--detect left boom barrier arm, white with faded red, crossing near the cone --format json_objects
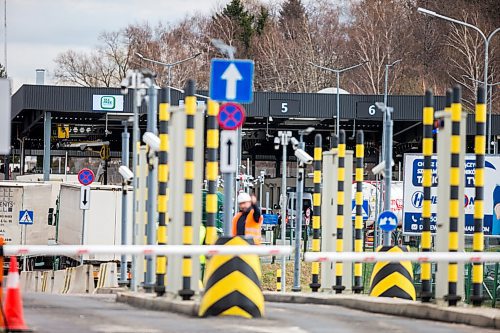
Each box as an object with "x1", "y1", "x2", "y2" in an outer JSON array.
[{"x1": 3, "y1": 245, "x2": 292, "y2": 256}]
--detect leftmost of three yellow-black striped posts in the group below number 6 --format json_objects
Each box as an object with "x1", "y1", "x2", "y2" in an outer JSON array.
[{"x1": 309, "y1": 134, "x2": 323, "y2": 292}]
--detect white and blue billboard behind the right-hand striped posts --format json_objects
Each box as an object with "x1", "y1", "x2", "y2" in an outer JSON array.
[{"x1": 403, "y1": 154, "x2": 500, "y2": 237}]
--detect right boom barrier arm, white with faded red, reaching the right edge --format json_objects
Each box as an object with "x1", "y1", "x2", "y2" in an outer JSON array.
[{"x1": 304, "y1": 252, "x2": 500, "y2": 262}]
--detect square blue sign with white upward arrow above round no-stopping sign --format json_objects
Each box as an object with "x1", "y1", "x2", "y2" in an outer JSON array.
[{"x1": 210, "y1": 59, "x2": 254, "y2": 103}]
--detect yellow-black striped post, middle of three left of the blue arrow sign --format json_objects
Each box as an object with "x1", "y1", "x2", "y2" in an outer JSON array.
[{"x1": 179, "y1": 80, "x2": 196, "y2": 300}]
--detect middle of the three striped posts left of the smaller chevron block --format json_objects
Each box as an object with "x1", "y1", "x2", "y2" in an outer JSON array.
[{"x1": 332, "y1": 130, "x2": 345, "y2": 294}]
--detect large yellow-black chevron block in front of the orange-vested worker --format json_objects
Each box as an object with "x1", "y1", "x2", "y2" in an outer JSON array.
[{"x1": 198, "y1": 236, "x2": 264, "y2": 318}]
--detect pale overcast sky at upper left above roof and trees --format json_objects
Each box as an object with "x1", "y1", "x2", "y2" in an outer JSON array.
[{"x1": 0, "y1": 0, "x2": 238, "y2": 89}]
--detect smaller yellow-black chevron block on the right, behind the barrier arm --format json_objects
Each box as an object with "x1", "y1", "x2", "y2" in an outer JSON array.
[{"x1": 370, "y1": 246, "x2": 416, "y2": 301}]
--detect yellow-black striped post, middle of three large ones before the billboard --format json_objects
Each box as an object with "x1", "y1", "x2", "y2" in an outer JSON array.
[{"x1": 444, "y1": 87, "x2": 462, "y2": 306}]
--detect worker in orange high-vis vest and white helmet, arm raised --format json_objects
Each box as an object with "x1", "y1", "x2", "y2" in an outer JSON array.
[{"x1": 232, "y1": 192, "x2": 263, "y2": 244}]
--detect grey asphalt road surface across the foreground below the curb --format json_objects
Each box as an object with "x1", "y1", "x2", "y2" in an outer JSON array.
[{"x1": 24, "y1": 294, "x2": 498, "y2": 333}]
